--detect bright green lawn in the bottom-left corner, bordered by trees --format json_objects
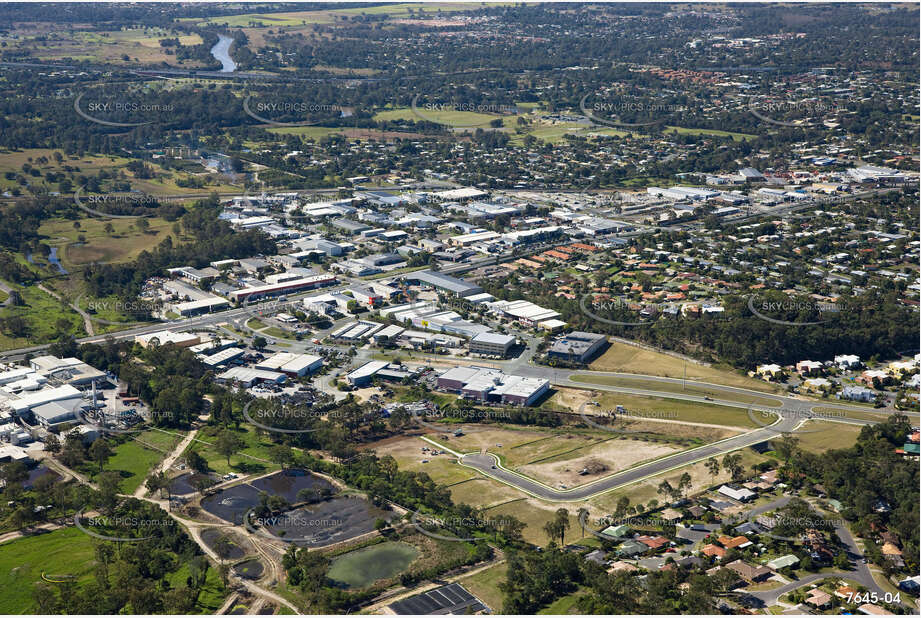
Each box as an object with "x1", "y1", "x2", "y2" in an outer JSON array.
[{"x1": 0, "y1": 528, "x2": 96, "y2": 614}]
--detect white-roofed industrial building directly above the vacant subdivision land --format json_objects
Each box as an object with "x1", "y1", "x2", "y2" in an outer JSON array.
[{"x1": 437, "y1": 366, "x2": 550, "y2": 406}]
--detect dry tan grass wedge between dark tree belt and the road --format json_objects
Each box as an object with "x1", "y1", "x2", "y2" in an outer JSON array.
[{"x1": 589, "y1": 341, "x2": 778, "y2": 393}]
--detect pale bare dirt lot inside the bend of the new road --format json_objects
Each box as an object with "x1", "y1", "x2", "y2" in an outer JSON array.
[{"x1": 516, "y1": 439, "x2": 680, "y2": 487}]
